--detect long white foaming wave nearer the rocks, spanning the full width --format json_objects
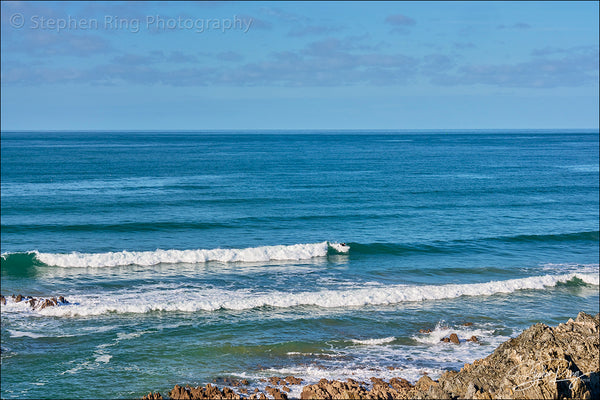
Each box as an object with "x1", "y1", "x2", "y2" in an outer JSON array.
[{"x1": 2, "y1": 273, "x2": 599, "y2": 316}]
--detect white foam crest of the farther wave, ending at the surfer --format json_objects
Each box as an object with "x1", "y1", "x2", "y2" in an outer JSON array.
[{"x1": 34, "y1": 242, "x2": 350, "y2": 268}]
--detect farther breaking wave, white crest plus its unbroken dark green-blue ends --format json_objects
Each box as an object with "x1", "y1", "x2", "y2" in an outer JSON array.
[{"x1": 1, "y1": 231, "x2": 600, "y2": 273}]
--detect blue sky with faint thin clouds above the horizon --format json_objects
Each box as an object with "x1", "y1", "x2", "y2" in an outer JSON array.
[{"x1": 0, "y1": 1, "x2": 599, "y2": 131}]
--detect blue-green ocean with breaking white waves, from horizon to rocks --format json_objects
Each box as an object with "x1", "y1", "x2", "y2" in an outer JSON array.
[{"x1": 0, "y1": 130, "x2": 599, "y2": 398}]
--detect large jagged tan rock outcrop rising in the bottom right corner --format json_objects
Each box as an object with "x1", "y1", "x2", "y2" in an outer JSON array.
[{"x1": 418, "y1": 313, "x2": 600, "y2": 399}]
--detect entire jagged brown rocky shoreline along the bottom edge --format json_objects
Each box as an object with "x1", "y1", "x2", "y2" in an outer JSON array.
[{"x1": 142, "y1": 312, "x2": 600, "y2": 400}]
